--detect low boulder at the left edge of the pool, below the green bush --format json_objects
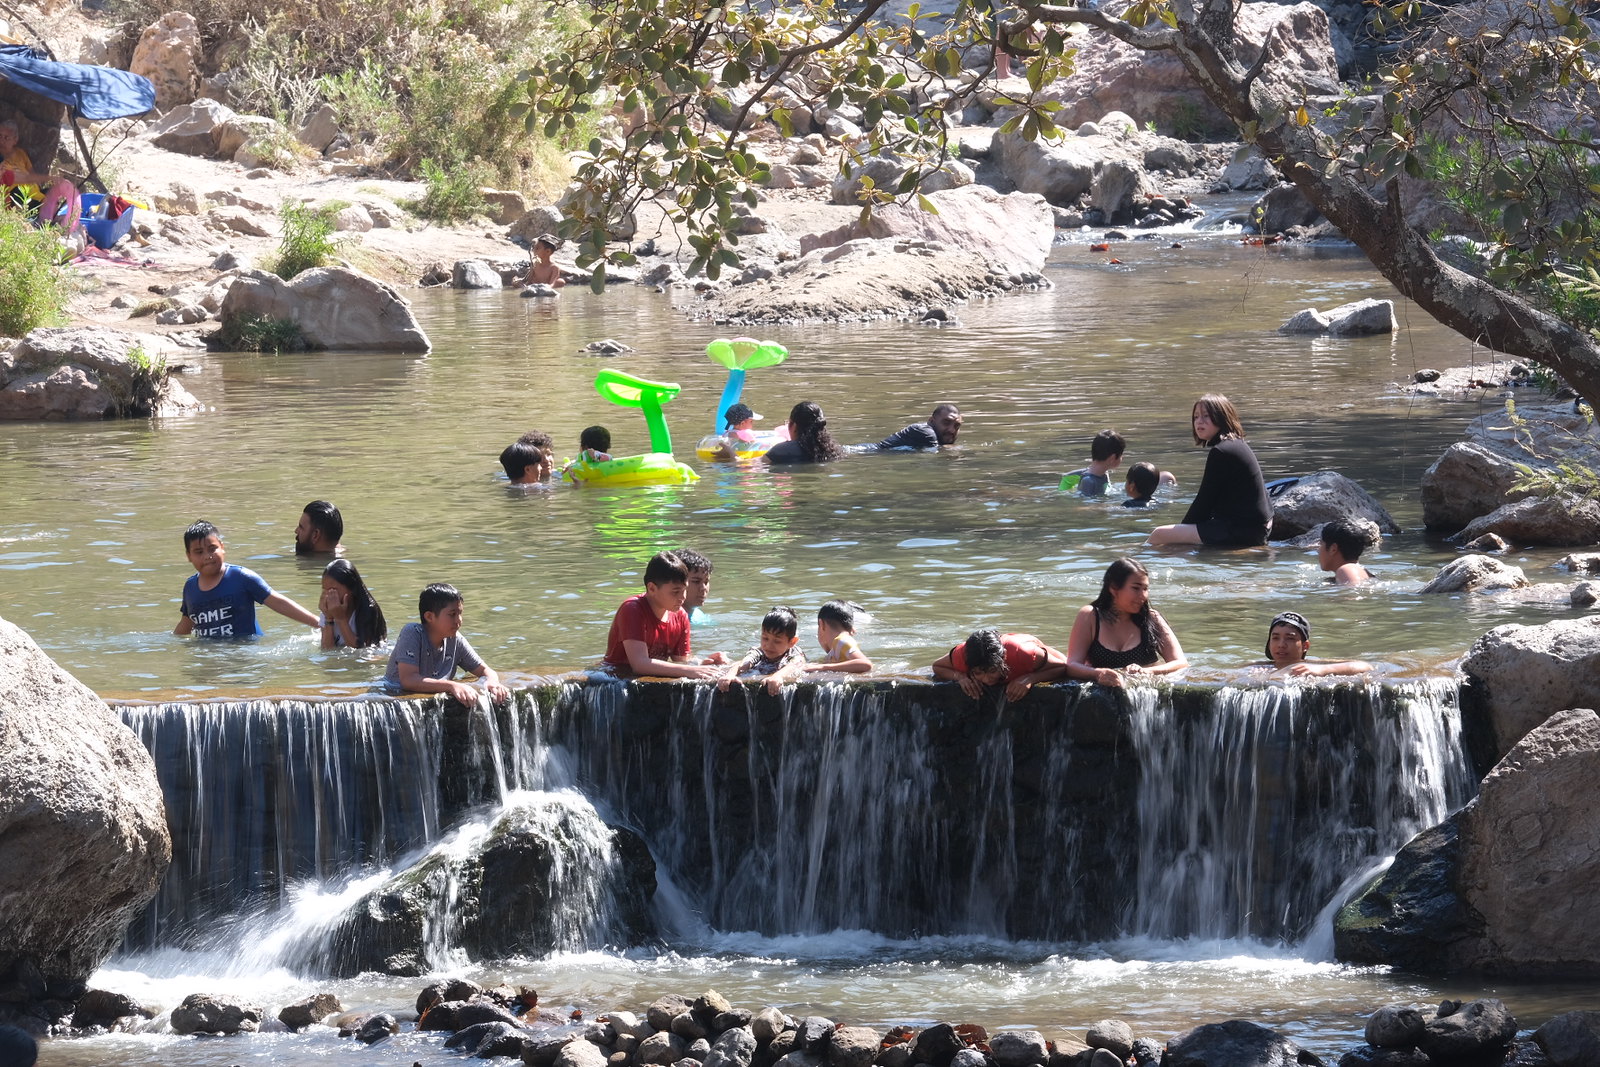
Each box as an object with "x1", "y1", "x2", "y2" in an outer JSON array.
[{"x1": 0, "y1": 326, "x2": 200, "y2": 419}]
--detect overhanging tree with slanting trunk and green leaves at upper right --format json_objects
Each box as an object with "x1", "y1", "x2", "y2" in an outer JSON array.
[{"x1": 520, "y1": 0, "x2": 1600, "y2": 402}]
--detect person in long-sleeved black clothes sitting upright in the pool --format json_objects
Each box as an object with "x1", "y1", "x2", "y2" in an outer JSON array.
[{"x1": 1150, "y1": 394, "x2": 1272, "y2": 547}]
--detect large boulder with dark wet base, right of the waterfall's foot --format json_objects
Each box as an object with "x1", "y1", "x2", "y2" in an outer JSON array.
[{"x1": 1334, "y1": 709, "x2": 1600, "y2": 979}]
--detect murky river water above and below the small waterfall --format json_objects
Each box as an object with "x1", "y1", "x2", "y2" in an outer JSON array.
[{"x1": 9, "y1": 220, "x2": 1594, "y2": 1065}]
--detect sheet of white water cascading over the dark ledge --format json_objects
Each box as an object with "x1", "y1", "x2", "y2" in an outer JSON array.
[{"x1": 122, "y1": 680, "x2": 1474, "y2": 966}]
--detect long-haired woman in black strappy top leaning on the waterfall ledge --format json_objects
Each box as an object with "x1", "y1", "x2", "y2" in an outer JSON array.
[{"x1": 1067, "y1": 557, "x2": 1189, "y2": 686}]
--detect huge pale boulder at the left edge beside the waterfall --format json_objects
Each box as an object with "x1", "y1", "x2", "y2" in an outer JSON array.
[{"x1": 0, "y1": 619, "x2": 173, "y2": 1030}]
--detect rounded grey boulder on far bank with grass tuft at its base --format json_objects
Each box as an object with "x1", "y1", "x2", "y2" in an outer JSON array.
[{"x1": 218, "y1": 267, "x2": 430, "y2": 352}]
